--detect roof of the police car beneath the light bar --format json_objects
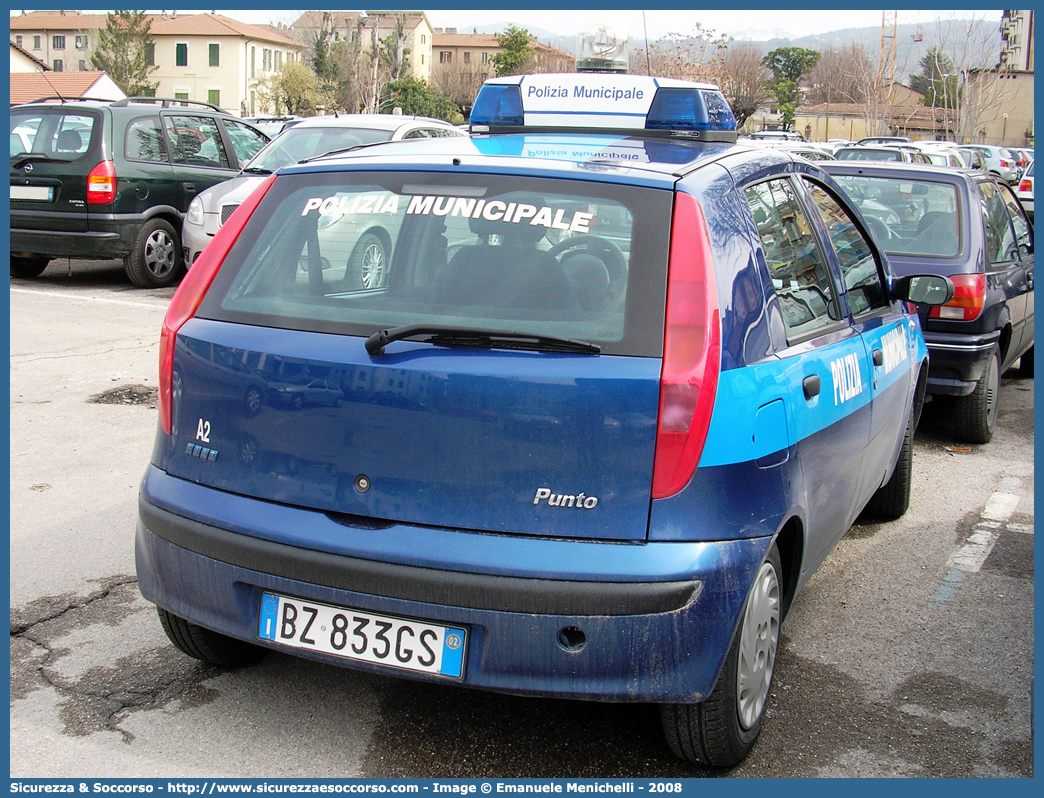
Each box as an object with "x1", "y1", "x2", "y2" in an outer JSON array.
[{"x1": 280, "y1": 133, "x2": 794, "y2": 185}]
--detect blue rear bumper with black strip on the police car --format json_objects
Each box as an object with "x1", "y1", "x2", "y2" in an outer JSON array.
[{"x1": 136, "y1": 467, "x2": 770, "y2": 703}]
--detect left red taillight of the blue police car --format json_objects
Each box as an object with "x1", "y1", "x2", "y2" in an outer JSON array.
[{"x1": 157, "y1": 175, "x2": 276, "y2": 435}]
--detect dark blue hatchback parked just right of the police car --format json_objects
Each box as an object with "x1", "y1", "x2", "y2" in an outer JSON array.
[{"x1": 824, "y1": 163, "x2": 1034, "y2": 443}]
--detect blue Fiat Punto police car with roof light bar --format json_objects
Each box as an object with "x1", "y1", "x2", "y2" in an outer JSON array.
[{"x1": 137, "y1": 74, "x2": 952, "y2": 766}]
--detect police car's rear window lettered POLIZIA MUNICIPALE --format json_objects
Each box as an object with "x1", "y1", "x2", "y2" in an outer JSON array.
[{"x1": 198, "y1": 171, "x2": 673, "y2": 356}]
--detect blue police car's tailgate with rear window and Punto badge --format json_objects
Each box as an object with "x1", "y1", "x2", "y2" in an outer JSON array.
[{"x1": 163, "y1": 168, "x2": 672, "y2": 540}]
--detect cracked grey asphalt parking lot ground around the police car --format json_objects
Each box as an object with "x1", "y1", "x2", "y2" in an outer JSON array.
[{"x1": 10, "y1": 261, "x2": 1034, "y2": 777}]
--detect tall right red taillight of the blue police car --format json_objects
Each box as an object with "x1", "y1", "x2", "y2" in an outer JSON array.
[{"x1": 653, "y1": 193, "x2": 721, "y2": 498}]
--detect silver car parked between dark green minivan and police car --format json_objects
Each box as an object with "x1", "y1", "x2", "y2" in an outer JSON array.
[{"x1": 182, "y1": 114, "x2": 467, "y2": 277}]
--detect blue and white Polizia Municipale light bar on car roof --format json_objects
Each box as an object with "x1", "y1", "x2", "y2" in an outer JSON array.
[{"x1": 471, "y1": 73, "x2": 736, "y2": 142}]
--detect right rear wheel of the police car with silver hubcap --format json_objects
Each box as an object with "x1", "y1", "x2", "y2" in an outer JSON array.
[{"x1": 660, "y1": 544, "x2": 783, "y2": 768}]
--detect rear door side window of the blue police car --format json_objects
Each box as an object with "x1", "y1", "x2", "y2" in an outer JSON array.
[{"x1": 744, "y1": 178, "x2": 840, "y2": 343}]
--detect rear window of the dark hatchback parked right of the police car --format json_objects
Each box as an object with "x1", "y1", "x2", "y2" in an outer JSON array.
[{"x1": 834, "y1": 174, "x2": 963, "y2": 258}]
